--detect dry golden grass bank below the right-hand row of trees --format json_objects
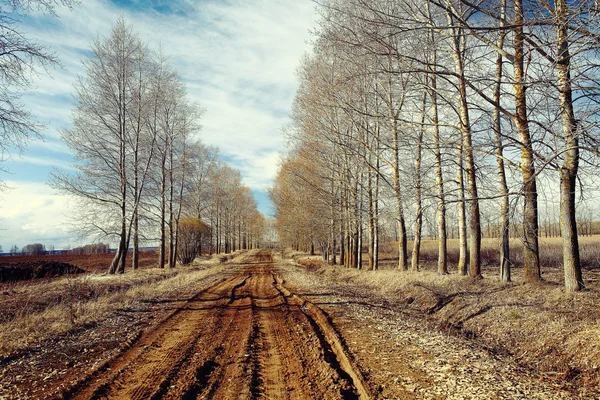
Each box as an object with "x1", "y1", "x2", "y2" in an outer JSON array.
[{"x1": 286, "y1": 253, "x2": 600, "y2": 390}]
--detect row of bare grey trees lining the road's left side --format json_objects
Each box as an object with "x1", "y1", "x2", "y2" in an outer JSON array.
[{"x1": 51, "y1": 19, "x2": 262, "y2": 273}]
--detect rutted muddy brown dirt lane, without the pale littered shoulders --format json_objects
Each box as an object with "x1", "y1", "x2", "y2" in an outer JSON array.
[{"x1": 65, "y1": 250, "x2": 370, "y2": 399}]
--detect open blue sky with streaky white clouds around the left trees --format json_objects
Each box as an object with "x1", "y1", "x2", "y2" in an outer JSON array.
[{"x1": 0, "y1": 0, "x2": 317, "y2": 251}]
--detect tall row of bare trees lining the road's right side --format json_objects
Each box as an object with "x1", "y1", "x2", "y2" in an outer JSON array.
[{"x1": 272, "y1": 0, "x2": 600, "y2": 291}]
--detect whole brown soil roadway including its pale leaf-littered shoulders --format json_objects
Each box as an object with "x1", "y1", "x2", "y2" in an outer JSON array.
[{"x1": 0, "y1": 250, "x2": 594, "y2": 399}]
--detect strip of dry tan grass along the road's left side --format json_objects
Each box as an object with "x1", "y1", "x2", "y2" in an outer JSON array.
[{"x1": 0, "y1": 257, "x2": 224, "y2": 358}]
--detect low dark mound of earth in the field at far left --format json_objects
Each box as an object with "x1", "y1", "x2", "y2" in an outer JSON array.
[{"x1": 0, "y1": 260, "x2": 85, "y2": 282}]
